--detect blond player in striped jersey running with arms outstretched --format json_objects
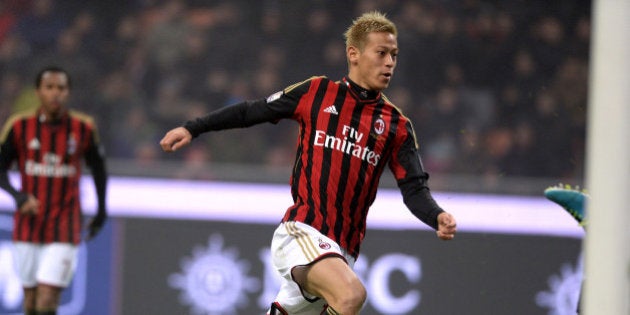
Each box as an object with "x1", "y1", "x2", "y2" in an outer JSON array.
[{"x1": 160, "y1": 12, "x2": 456, "y2": 315}]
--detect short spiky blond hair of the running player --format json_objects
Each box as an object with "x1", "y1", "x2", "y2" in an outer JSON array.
[{"x1": 343, "y1": 11, "x2": 398, "y2": 51}]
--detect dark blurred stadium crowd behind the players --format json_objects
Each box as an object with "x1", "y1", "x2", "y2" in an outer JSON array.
[{"x1": 0, "y1": 0, "x2": 591, "y2": 188}]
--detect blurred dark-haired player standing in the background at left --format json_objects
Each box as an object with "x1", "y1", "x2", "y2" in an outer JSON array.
[{"x1": 0, "y1": 67, "x2": 107, "y2": 315}]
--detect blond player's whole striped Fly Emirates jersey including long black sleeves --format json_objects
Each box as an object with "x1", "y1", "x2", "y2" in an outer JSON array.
[{"x1": 184, "y1": 77, "x2": 443, "y2": 257}]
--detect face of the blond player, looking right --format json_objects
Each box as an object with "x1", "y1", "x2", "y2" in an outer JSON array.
[{"x1": 356, "y1": 32, "x2": 398, "y2": 91}]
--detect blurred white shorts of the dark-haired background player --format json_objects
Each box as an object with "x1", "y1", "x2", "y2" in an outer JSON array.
[{"x1": 13, "y1": 242, "x2": 78, "y2": 288}]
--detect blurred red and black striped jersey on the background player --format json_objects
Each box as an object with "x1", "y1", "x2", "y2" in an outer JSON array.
[{"x1": 0, "y1": 110, "x2": 102, "y2": 244}]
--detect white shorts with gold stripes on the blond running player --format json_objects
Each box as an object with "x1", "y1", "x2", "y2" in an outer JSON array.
[{"x1": 268, "y1": 221, "x2": 354, "y2": 315}]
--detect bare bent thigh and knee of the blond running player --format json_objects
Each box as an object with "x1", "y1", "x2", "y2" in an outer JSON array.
[{"x1": 293, "y1": 256, "x2": 364, "y2": 299}]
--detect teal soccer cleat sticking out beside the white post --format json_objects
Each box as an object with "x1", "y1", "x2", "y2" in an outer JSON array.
[{"x1": 544, "y1": 184, "x2": 589, "y2": 226}]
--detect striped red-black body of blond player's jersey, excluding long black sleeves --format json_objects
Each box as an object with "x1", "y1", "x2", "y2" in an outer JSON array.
[{"x1": 283, "y1": 78, "x2": 442, "y2": 256}]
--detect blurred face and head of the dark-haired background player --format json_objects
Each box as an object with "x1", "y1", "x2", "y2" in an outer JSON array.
[{"x1": 37, "y1": 72, "x2": 70, "y2": 116}]
